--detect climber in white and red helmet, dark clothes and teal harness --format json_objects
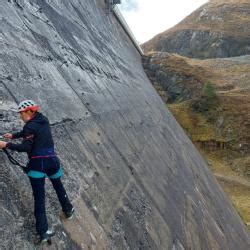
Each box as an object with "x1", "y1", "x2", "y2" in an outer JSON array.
[{"x1": 0, "y1": 100, "x2": 74, "y2": 243}]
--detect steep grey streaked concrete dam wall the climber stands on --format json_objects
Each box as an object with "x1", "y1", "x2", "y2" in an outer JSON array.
[{"x1": 0, "y1": 0, "x2": 250, "y2": 250}]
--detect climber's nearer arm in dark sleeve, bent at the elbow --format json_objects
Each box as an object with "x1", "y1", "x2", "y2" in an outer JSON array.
[{"x1": 6, "y1": 126, "x2": 35, "y2": 153}]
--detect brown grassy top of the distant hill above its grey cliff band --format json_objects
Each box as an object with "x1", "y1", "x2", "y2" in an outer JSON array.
[{"x1": 167, "y1": 1, "x2": 250, "y2": 37}]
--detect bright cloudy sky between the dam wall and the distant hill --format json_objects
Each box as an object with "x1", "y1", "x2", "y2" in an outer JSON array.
[{"x1": 118, "y1": 0, "x2": 208, "y2": 43}]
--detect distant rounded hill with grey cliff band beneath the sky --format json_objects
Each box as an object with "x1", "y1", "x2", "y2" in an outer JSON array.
[{"x1": 143, "y1": 0, "x2": 250, "y2": 58}]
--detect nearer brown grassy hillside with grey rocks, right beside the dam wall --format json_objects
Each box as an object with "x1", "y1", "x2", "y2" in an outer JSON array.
[{"x1": 143, "y1": 52, "x2": 250, "y2": 224}]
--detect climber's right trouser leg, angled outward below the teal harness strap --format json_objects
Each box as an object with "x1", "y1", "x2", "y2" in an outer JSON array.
[{"x1": 50, "y1": 177, "x2": 73, "y2": 213}]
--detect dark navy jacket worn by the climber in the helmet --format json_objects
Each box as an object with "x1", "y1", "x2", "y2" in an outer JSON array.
[{"x1": 7, "y1": 112, "x2": 54, "y2": 159}]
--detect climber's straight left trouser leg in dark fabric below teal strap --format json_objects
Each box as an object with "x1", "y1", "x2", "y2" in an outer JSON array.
[{"x1": 29, "y1": 177, "x2": 48, "y2": 236}]
